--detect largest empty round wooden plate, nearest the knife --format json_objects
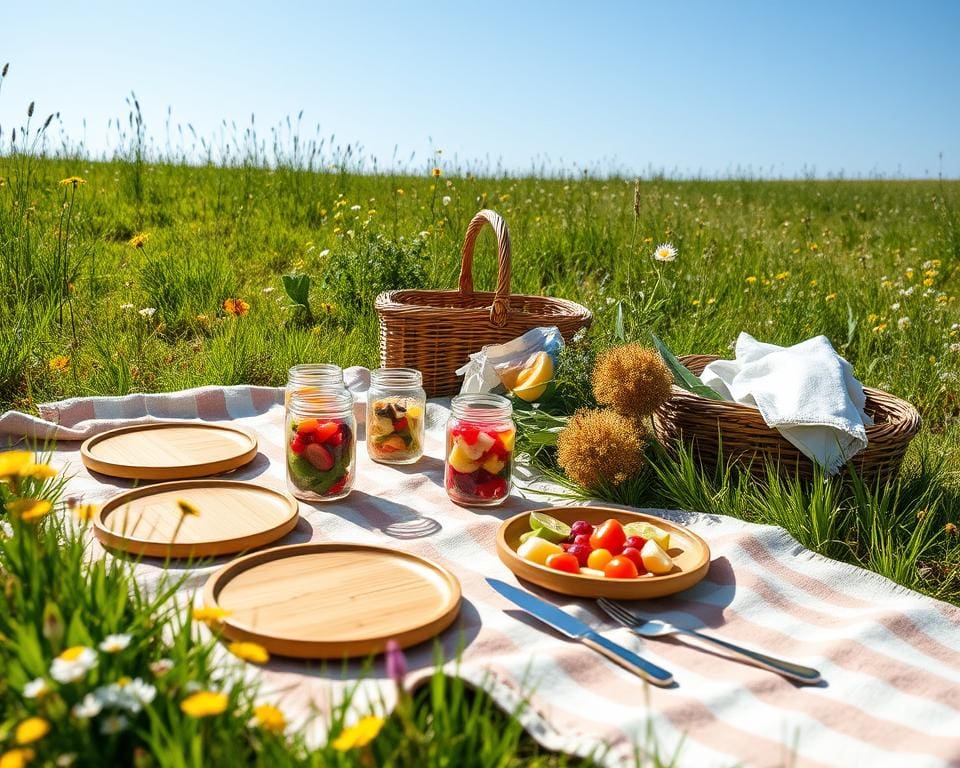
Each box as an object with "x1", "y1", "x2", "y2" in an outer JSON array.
[{"x1": 204, "y1": 543, "x2": 460, "y2": 659}]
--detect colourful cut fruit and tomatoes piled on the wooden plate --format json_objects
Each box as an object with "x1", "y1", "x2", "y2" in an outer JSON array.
[{"x1": 517, "y1": 512, "x2": 675, "y2": 579}]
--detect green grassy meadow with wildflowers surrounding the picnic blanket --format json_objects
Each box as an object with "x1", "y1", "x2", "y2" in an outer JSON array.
[{"x1": 0, "y1": 97, "x2": 960, "y2": 765}]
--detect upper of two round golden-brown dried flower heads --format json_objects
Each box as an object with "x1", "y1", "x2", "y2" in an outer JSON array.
[{"x1": 593, "y1": 344, "x2": 673, "y2": 417}]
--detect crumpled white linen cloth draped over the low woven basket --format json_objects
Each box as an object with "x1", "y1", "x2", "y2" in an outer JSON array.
[{"x1": 700, "y1": 333, "x2": 873, "y2": 475}]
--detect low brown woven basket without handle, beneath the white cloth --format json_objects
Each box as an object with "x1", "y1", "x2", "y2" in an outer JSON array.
[{"x1": 653, "y1": 355, "x2": 920, "y2": 483}]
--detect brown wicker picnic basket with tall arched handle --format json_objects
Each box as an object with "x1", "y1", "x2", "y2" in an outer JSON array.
[{"x1": 376, "y1": 210, "x2": 593, "y2": 397}]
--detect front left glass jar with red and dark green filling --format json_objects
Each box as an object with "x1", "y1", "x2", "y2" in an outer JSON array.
[{"x1": 284, "y1": 389, "x2": 357, "y2": 501}]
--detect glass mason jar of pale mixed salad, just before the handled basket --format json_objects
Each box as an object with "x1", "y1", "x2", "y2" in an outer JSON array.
[{"x1": 367, "y1": 368, "x2": 427, "y2": 464}]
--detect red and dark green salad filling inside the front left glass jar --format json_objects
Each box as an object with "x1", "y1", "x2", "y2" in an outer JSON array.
[{"x1": 287, "y1": 418, "x2": 356, "y2": 500}]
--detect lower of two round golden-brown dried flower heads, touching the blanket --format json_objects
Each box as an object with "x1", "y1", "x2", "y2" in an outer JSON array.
[{"x1": 557, "y1": 410, "x2": 646, "y2": 488}]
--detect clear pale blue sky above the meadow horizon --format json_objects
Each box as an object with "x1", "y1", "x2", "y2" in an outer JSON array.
[{"x1": 0, "y1": 0, "x2": 960, "y2": 177}]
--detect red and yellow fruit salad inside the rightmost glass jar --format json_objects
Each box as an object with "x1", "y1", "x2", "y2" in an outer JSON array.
[{"x1": 445, "y1": 421, "x2": 516, "y2": 506}]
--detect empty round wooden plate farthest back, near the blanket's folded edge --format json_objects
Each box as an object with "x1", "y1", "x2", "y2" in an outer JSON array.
[{"x1": 80, "y1": 421, "x2": 257, "y2": 480}]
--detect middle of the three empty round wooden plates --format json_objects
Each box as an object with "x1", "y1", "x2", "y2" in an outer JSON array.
[{"x1": 94, "y1": 480, "x2": 300, "y2": 557}]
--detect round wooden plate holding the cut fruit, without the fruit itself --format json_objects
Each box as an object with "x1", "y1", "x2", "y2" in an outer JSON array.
[{"x1": 497, "y1": 507, "x2": 710, "y2": 600}]
